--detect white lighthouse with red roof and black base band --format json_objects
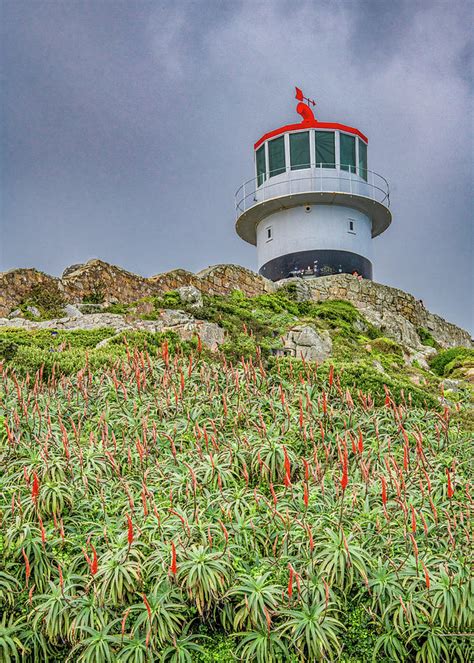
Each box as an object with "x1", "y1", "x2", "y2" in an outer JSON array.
[{"x1": 235, "y1": 88, "x2": 392, "y2": 281}]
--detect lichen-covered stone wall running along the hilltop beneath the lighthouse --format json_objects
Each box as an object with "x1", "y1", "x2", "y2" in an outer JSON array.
[{"x1": 0, "y1": 260, "x2": 471, "y2": 350}]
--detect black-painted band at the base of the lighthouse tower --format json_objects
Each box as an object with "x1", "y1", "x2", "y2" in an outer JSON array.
[{"x1": 259, "y1": 249, "x2": 372, "y2": 281}]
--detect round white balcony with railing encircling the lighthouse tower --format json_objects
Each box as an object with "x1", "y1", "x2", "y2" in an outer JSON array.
[{"x1": 235, "y1": 167, "x2": 392, "y2": 244}]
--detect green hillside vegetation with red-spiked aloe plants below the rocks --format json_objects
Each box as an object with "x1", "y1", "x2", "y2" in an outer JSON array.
[{"x1": 0, "y1": 290, "x2": 474, "y2": 663}]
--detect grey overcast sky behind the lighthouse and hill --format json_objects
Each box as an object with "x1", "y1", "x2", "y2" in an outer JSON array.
[{"x1": 0, "y1": 0, "x2": 474, "y2": 329}]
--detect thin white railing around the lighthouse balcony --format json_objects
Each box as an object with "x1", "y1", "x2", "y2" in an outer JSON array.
[{"x1": 235, "y1": 166, "x2": 390, "y2": 218}]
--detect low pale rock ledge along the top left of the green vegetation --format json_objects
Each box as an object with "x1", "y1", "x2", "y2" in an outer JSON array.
[{"x1": 0, "y1": 309, "x2": 225, "y2": 351}]
